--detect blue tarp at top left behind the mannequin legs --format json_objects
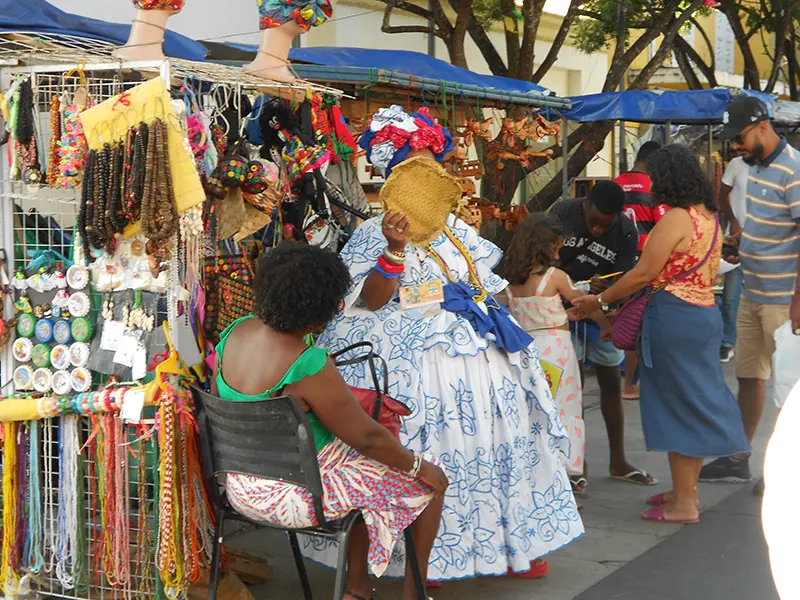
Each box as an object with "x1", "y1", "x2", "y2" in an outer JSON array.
[{"x1": 0, "y1": 0, "x2": 206, "y2": 61}]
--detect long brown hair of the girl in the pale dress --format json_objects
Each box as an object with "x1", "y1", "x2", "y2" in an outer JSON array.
[{"x1": 505, "y1": 213, "x2": 564, "y2": 285}]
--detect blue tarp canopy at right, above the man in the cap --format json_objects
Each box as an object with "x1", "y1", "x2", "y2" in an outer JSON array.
[{"x1": 562, "y1": 88, "x2": 775, "y2": 125}]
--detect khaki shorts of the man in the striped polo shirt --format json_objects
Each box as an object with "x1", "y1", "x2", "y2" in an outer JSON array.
[{"x1": 736, "y1": 298, "x2": 789, "y2": 380}]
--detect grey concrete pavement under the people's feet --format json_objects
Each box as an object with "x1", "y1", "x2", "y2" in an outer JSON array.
[{"x1": 226, "y1": 366, "x2": 777, "y2": 600}]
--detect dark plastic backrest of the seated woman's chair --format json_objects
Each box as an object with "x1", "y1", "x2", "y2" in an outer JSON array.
[{"x1": 192, "y1": 387, "x2": 326, "y2": 527}]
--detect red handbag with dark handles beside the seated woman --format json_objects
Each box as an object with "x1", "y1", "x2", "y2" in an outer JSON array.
[{"x1": 331, "y1": 342, "x2": 411, "y2": 439}]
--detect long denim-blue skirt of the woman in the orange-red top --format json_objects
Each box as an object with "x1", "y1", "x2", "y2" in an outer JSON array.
[{"x1": 638, "y1": 291, "x2": 750, "y2": 458}]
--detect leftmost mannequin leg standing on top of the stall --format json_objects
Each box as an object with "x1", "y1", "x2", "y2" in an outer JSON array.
[{"x1": 113, "y1": 0, "x2": 184, "y2": 61}]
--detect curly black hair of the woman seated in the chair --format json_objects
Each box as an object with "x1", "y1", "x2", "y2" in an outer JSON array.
[{"x1": 253, "y1": 242, "x2": 350, "y2": 334}]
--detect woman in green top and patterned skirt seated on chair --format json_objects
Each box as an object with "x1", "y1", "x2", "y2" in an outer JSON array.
[{"x1": 212, "y1": 243, "x2": 448, "y2": 600}]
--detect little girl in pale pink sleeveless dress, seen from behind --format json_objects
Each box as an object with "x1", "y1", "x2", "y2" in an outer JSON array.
[{"x1": 505, "y1": 213, "x2": 610, "y2": 475}]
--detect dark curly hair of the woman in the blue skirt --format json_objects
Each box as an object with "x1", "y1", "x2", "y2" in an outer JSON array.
[{"x1": 647, "y1": 144, "x2": 717, "y2": 212}]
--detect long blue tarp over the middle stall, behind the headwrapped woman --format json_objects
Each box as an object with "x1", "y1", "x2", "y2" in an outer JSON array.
[{"x1": 289, "y1": 47, "x2": 550, "y2": 94}]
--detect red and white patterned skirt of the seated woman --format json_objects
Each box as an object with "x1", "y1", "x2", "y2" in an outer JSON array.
[{"x1": 227, "y1": 439, "x2": 433, "y2": 577}]
